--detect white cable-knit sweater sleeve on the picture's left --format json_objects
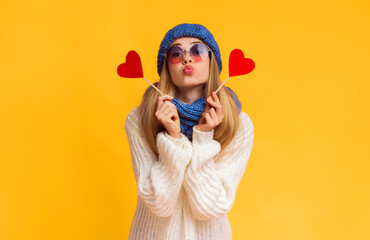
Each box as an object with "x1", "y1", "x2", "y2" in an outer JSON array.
[{"x1": 125, "y1": 108, "x2": 192, "y2": 217}]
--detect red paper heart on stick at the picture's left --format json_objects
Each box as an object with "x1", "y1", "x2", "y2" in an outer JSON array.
[{"x1": 117, "y1": 50, "x2": 144, "y2": 78}]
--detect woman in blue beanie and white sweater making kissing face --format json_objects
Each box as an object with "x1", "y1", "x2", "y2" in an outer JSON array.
[{"x1": 125, "y1": 24, "x2": 254, "y2": 240}]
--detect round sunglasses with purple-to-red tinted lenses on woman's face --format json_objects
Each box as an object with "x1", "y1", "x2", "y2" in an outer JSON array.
[{"x1": 164, "y1": 43, "x2": 211, "y2": 64}]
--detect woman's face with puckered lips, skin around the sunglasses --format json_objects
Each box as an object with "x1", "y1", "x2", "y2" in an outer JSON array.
[{"x1": 167, "y1": 37, "x2": 210, "y2": 88}]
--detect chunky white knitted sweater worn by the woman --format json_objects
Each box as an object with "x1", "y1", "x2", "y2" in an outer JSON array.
[{"x1": 125, "y1": 108, "x2": 254, "y2": 240}]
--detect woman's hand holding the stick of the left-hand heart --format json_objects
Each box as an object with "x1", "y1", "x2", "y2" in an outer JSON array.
[{"x1": 155, "y1": 94, "x2": 181, "y2": 138}]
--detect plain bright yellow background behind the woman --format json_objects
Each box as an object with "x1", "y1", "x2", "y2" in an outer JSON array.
[{"x1": 0, "y1": 0, "x2": 370, "y2": 240}]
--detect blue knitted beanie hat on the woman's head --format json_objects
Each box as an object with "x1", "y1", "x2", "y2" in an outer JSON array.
[{"x1": 157, "y1": 23, "x2": 222, "y2": 75}]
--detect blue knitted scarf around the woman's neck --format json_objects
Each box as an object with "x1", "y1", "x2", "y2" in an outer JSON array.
[{"x1": 171, "y1": 87, "x2": 241, "y2": 141}]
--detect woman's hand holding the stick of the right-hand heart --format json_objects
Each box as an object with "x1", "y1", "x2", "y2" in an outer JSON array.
[{"x1": 195, "y1": 92, "x2": 224, "y2": 132}]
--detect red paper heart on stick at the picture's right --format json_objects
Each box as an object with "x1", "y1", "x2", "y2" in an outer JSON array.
[{"x1": 229, "y1": 49, "x2": 255, "y2": 77}]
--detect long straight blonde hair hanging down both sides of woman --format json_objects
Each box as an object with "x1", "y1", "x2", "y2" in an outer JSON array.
[{"x1": 137, "y1": 51, "x2": 239, "y2": 157}]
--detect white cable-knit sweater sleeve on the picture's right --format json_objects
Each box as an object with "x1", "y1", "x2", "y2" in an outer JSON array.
[{"x1": 184, "y1": 112, "x2": 254, "y2": 220}]
